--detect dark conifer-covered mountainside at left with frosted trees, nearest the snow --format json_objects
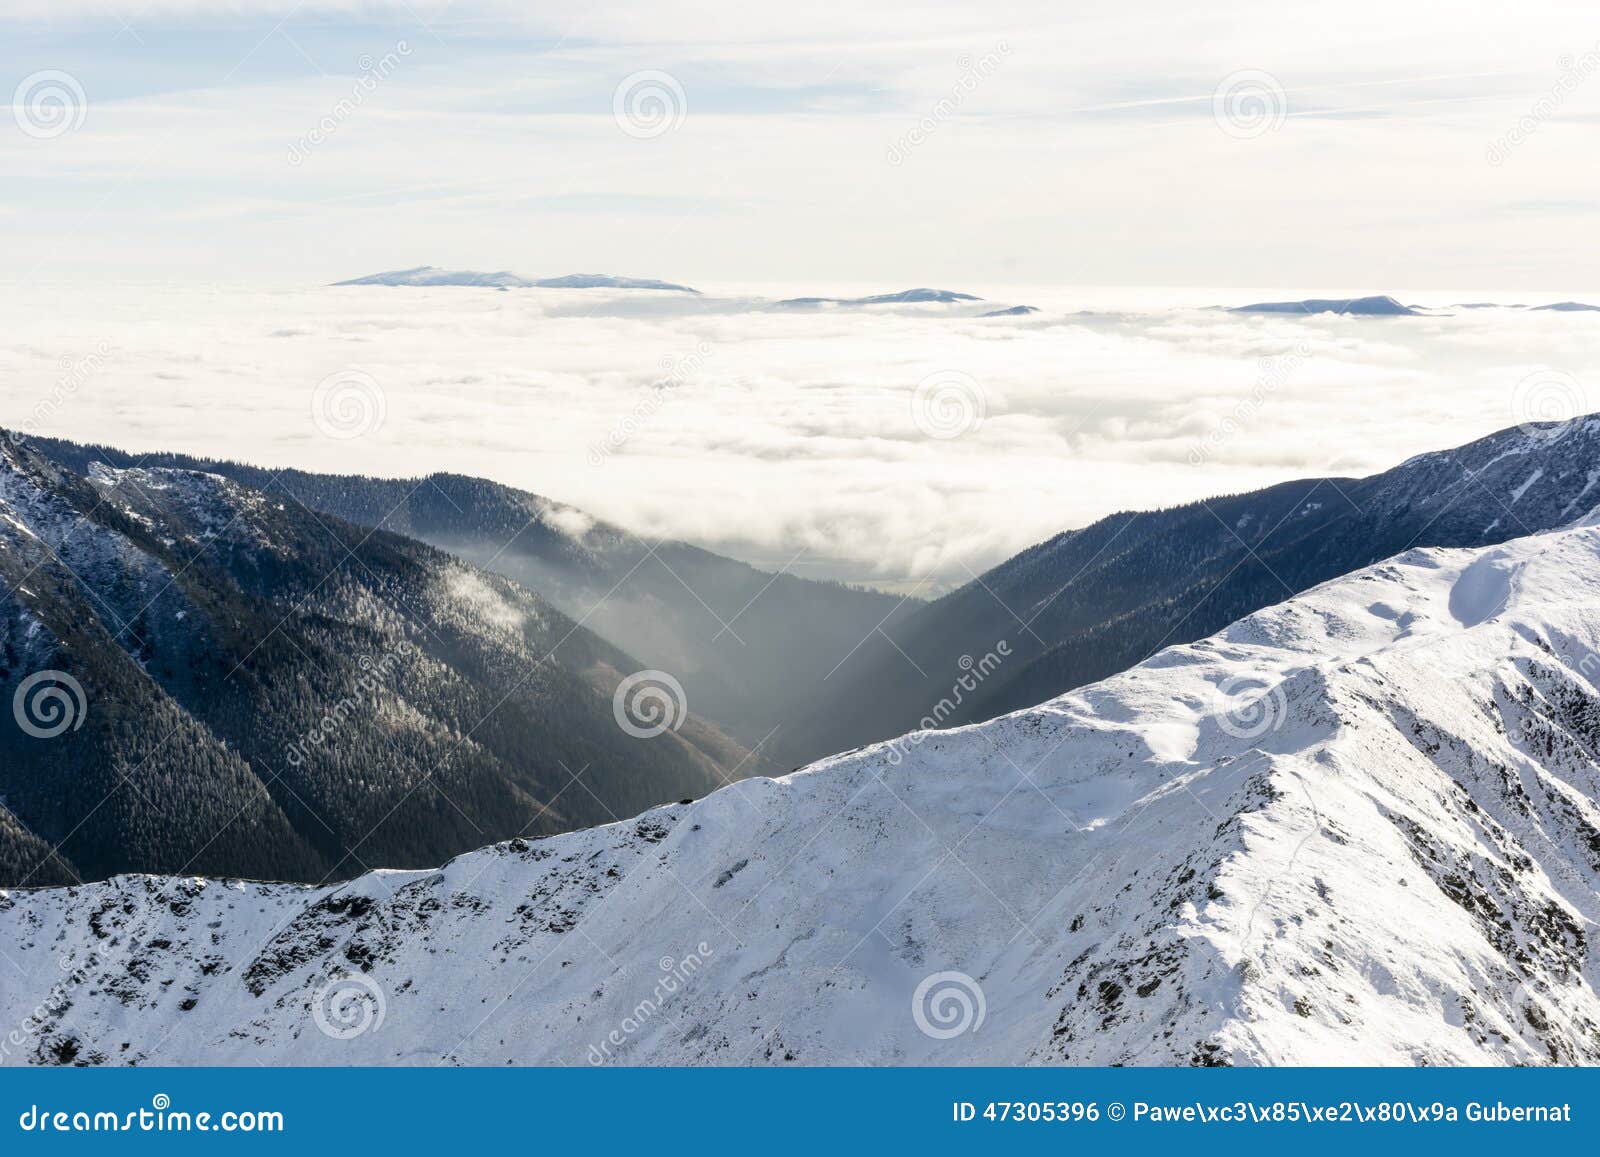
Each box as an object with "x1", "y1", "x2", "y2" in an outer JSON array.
[{"x1": 0, "y1": 440, "x2": 760, "y2": 883}]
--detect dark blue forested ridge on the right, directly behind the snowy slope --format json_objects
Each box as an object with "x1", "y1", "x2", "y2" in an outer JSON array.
[{"x1": 782, "y1": 416, "x2": 1600, "y2": 762}]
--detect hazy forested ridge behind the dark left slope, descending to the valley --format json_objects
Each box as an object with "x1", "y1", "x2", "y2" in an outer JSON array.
[{"x1": 34, "y1": 438, "x2": 923, "y2": 747}]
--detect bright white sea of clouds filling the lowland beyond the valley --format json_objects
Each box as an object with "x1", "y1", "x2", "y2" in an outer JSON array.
[{"x1": 0, "y1": 286, "x2": 1600, "y2": 594}]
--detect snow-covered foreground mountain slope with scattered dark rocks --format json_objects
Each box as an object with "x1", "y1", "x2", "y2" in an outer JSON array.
[{"x1": 9, "y1": 528, "x2": 1600, "y2": 1064}]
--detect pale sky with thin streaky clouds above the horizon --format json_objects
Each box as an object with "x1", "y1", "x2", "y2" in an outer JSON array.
[{"x1": 0, "y1": 0, "x2": 1600, "y2": 291}]
